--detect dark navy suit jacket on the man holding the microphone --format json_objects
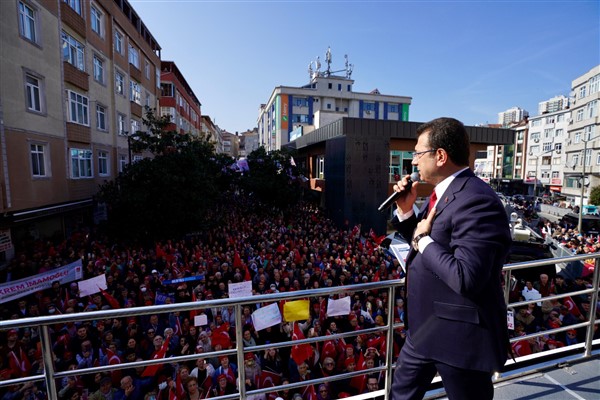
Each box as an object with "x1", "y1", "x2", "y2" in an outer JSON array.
[{"x1": 392, "y1": 170, "x2": 511, "y2": 371}]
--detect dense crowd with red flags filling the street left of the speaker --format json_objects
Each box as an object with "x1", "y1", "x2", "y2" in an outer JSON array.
[{"x1": 0, "y1": 201, "x2": 405, "y2": 400}]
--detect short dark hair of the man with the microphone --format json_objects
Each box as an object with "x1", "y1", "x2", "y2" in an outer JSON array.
[{"x1": 417, "y1": 118, "x2": 471, "y2": 166}]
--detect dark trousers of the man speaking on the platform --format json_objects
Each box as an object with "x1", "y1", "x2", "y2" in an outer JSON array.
[{"x1": 392, "y1": 339, "x2": 494, "y2": 400}]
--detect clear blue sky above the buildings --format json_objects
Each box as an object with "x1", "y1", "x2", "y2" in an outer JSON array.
[{"x1": 130, "y1": 0, "x2": 600, "y2": 133}]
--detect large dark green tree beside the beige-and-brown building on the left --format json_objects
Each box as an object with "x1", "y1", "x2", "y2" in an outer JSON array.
[{"x1": 96, "y1": 108, "x2": 220, "y2": 241}]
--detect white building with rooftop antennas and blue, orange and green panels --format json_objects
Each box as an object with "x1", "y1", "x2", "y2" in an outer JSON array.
[{"x1": 257, "y1": 50, "x2": 412, "y2": 151}]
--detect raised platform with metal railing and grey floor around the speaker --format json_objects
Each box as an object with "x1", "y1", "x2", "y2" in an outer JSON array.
[{"x1": 0, "y1": 253, "x2": 600, "y2": 400}]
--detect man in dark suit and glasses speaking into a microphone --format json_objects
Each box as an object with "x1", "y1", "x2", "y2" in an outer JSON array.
[{"x1": 392, "y1": 118, "x2": 511, "y2": 400}]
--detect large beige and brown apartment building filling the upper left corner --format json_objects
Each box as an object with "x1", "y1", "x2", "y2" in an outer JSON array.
[{"x1": 0, "y1": 0, "x2": 161, "y2": 257}]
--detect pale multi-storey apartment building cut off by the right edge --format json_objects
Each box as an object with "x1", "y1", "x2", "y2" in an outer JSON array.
[{"x1": 563, "y1": 65, "x2": 600, "y2": 205}]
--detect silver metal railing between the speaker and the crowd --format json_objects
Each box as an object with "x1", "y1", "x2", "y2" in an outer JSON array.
[{"x1": 0, "y1": 253, "x2": 600, "y2": 400}]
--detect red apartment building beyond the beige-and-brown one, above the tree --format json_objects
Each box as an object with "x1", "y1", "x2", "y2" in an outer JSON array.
[{"x1": 159, "y1": 61, "x2": 202, "y2": 137}]
